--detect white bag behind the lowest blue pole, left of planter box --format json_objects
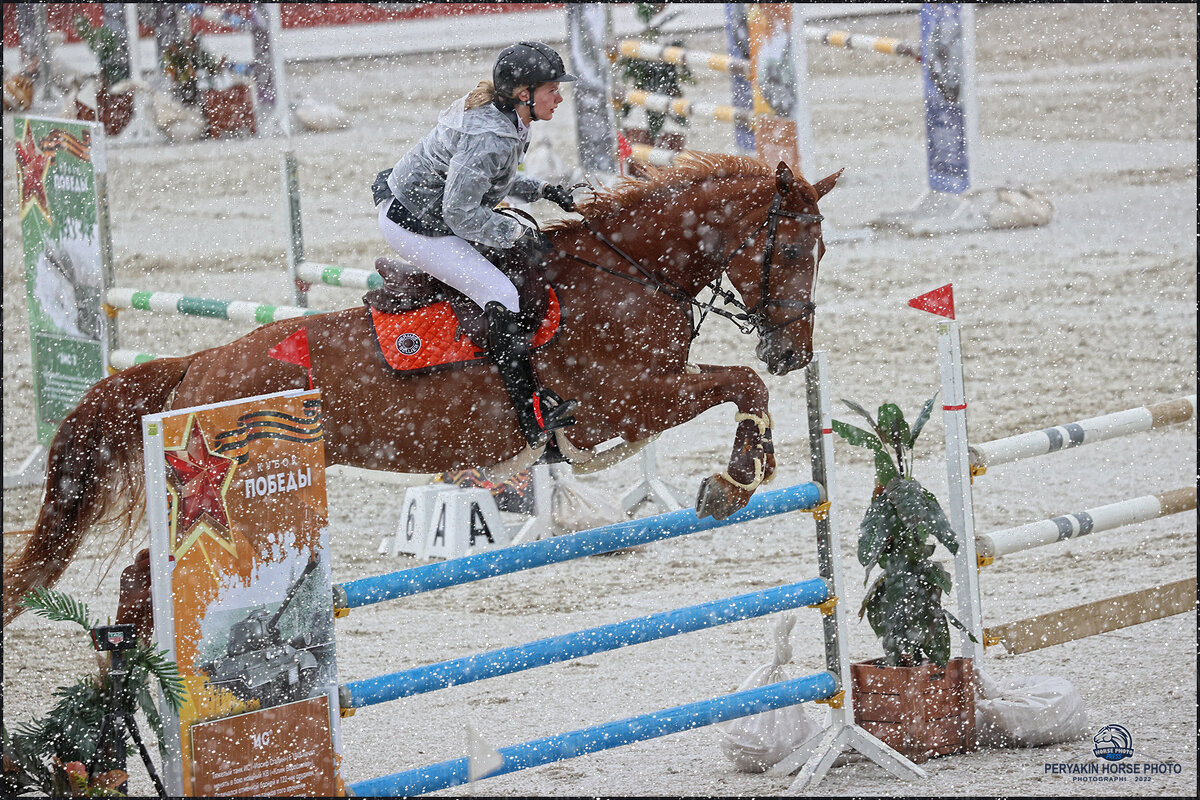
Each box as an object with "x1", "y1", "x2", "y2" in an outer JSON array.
[{"x1": 715, "y1": 614, "x2": 821, "y2": 772}]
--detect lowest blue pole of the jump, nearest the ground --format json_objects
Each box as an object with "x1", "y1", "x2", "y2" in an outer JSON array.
[{"x1": 349, "y1": 672, "x2": 838, "y2": 798}]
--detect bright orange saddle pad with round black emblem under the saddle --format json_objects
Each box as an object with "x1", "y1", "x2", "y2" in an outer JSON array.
[{"x1": 371, "y1": 289, "x2": 560, "y2": 372}]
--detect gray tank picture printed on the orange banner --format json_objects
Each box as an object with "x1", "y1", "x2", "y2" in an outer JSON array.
[{"x1": 199, "y1": 559, "x2": 320, "y2": 708}]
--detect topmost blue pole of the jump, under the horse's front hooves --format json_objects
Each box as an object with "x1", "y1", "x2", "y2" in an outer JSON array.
[{"x1": 334, "y1": 483, "x2": 824, "y2": 608}]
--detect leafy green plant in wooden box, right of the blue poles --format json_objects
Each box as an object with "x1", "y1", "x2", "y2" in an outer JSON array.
[{"x1": 833, "y1": 395, "x2": 976, "y2": 762}]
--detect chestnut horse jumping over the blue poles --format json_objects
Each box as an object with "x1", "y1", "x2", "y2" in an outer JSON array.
[{"x1": 4, "y1": 152, "x2": 841, "y2": 625}]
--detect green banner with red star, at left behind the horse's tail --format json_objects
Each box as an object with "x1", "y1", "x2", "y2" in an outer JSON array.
[{"x1": 13, "y1": 116, "x2": 112, "y2": 445}]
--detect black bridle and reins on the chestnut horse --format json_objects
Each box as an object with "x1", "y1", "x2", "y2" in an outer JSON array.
[{"x1": 558, "y1": 184, "x2": 824, "y2": 339}]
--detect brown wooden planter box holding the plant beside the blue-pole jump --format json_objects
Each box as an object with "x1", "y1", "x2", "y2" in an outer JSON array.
[{"x1": 850, "y1": 658, "x2": 978, "y2": 763}]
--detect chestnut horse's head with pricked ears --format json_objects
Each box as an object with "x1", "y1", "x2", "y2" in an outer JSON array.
[{"x1": 728, "y1": 162, "x2": 841, "y2": 375}]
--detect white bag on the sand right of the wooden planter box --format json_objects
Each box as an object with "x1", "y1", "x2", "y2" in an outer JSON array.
[{"x1": 976, "y1": 668, "x2": 1091, "y2": 747}]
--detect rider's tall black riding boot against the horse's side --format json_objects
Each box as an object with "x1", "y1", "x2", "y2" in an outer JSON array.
[{"x1": 484, "y1": 302, "x2": 578, "y2": 447}]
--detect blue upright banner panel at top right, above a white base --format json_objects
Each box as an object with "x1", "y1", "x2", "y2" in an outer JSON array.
[{"x1": 920, "y1": 2, "x2": 974, "y2": 194}]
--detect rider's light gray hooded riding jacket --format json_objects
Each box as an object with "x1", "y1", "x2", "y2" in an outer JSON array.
[{"x1": 388, "y1": 97, "x2": 546, "y2": 249}]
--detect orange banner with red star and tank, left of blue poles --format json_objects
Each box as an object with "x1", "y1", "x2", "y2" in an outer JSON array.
[{"x1": 143, "y1": 391, "x2": 344, "y2": 796}]
